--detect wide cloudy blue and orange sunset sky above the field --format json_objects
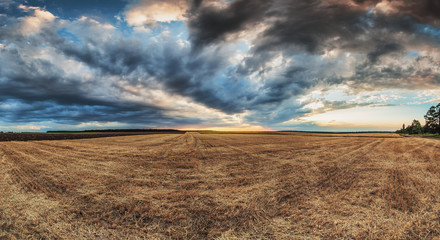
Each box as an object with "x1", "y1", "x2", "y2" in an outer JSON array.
[{"x1": 0, "y1": 0, "x2": 440, "y2": 131}]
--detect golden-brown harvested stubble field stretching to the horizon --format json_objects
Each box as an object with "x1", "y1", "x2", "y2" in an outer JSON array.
[{"x1": 0, "y1": 133, "x2": 440, "y2": 239}]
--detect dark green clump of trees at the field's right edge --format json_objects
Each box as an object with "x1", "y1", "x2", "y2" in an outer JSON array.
[{"x1": 397, "y1": 103, "x2": 440, "y2": 134}]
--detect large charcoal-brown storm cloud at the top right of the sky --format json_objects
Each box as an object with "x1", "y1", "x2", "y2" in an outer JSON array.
[{"x1": 244, "y1": 0, "x2": 436, "y2": 57}]
